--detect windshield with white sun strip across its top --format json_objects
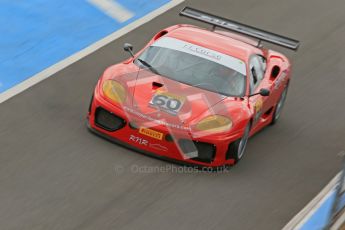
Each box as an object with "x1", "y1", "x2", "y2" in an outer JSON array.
[{"x1": 135, "y1": 38, "x2": 246, "y2": 97}]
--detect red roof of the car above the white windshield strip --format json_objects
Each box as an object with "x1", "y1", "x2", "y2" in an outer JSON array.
[{"x1": 167, "y1": 26, "x2": 259, "y2": 61}]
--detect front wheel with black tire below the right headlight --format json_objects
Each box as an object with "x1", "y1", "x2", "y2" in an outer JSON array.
[{"x1": 227, "y1": 124, "x2": 251, "y2": 164}]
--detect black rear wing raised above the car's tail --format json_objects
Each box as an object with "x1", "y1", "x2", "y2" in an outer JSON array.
[{"x1": 180, "y1": 7, "x2": 300, "y2": 51}]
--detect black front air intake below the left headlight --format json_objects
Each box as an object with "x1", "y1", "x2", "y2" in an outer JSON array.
[{"x1": 95, "y1": 107, "x2": 126, "y2": 132}]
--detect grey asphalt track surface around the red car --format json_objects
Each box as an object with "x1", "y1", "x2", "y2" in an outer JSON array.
[{"x1": 0, "y1": 0, "x2": 345, "y2": 230}]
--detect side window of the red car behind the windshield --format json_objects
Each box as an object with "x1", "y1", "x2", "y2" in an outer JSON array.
[{"x1": 249, "y1": 55, "x2": 266, "y2": 93}]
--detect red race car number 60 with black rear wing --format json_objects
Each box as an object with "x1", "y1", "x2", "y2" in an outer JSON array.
[{"x1": 88, "y1": 7, "x2": 299, "y2": 168}]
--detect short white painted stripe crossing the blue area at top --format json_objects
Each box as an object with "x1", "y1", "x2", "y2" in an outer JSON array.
[{"x1": 88, "y1": 0, "x2": 134, "y2": 23}]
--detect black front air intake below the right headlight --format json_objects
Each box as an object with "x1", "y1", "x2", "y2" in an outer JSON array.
[{"x1": 178, "y1": 139, "x2": 216, "y2": 163}]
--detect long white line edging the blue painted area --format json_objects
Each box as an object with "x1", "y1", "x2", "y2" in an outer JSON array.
[{"x1": 0, "y1": 0, "x2": 184, "y2": 103}]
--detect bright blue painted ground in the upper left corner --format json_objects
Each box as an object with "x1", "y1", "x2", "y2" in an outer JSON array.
[{"x1": 0, "y1": 0, "x2": 170, "y2": 93}]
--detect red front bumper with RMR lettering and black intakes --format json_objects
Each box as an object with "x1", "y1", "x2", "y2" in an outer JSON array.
[{"x1": 87, "y1": 90, "x2": 242, "y2": 168}]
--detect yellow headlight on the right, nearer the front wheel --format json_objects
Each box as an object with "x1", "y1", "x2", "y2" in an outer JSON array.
[{"x1": 196, "y1": 115, "x2": 232, "y2": 132}]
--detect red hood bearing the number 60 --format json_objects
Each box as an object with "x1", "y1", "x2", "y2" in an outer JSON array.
[{"x1": 116, "y1": 70, "x2": 231, "y2": 128}]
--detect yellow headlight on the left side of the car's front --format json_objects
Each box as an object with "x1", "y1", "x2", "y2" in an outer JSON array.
[{"x1": 103, "y1": 80, "x2": 126, "y2": 103}]
